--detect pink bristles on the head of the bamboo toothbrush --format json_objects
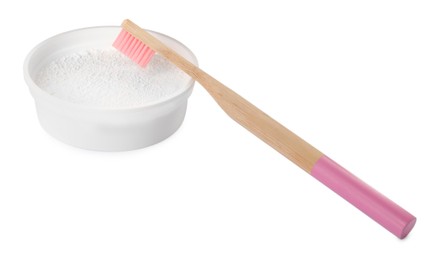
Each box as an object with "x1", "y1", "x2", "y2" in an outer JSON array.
[{"x1": 113, "y1": 29, "x2": 155, "y2": 67}]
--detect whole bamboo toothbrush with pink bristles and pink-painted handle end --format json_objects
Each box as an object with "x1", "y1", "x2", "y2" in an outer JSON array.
[{"x1": 113, "y1": 20, "x2": 416, "y2": 239}]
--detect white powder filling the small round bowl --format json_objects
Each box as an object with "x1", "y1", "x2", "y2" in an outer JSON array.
[{"x1": 35, "y1": 48, "x2": 190, "y2": 108}]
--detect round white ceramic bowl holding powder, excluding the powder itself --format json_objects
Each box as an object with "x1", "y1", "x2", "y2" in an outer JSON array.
[{"x1": 24, "y1": 26, "x2": 197, "y2": 151}]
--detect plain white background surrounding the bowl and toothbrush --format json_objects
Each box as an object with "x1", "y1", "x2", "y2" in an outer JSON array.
[{"x1": 0, "y1": 0, "x2": 433, "y2": 260}]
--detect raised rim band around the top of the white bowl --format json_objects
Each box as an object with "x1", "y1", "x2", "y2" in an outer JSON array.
[{"x1": 23, "y1": 26, "x2": 198, "y2": 112}]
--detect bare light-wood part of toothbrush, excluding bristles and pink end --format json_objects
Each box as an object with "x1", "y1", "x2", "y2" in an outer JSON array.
[{"x1": 122, "y1": 20, "x2": 323, "y2": 173}]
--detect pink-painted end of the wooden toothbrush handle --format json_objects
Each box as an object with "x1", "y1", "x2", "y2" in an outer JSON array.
[{"x1": 311, "y1": 155, "x2": 416, "y2": 239}]
